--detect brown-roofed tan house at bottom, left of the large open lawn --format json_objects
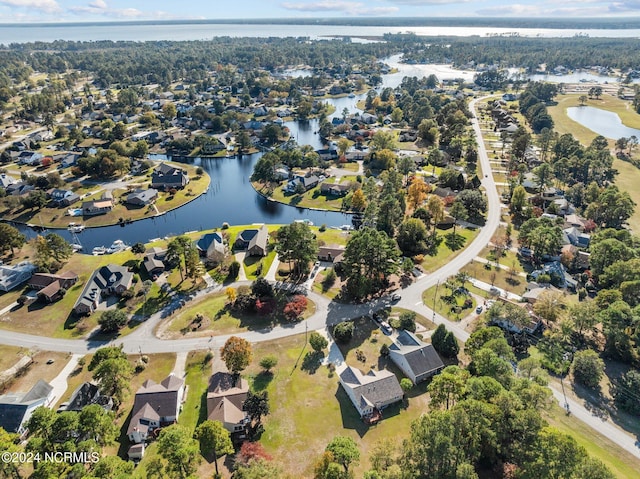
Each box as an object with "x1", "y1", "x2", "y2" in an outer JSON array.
[{"x1": 207, "y1": 371, "x2": 249, "y2": 439}]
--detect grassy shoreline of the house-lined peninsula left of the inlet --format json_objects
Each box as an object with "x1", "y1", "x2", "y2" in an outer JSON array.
[{"x1": 2, "y1": 163, "x2": 210, "y2": 228}]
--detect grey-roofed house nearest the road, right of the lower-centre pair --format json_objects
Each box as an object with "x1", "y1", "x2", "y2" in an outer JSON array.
[{"x1": 389, "y1": 330, "x2": 444, "y2": 384}]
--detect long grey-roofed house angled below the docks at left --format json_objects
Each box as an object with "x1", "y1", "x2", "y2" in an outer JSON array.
[{"x1": 73, "y1": 264, "x2": 133, "y2": 315}]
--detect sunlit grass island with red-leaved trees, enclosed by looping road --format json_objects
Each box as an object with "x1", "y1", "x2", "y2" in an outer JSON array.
[{"x1": 161, "y1": 293, "x2": 315, "y2": 338}]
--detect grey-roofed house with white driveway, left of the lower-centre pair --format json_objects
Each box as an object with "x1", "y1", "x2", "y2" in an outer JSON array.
[{"x1": 339, "y1": 366, "x2": 404, "y2": 421}]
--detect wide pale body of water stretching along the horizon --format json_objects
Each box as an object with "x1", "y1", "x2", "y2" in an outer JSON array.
[{"x1": 0, "y1": 24, "x2": 640, "y2": 45}]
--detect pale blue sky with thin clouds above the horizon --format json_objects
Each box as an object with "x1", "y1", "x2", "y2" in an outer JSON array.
[{"x1": 0, "y1": 0, "x2": 640, "y2": 23}]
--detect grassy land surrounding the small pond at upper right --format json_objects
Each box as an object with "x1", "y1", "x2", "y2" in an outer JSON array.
[{"x1": 549, "y1": 94, "x2": 640, "y2": 231}]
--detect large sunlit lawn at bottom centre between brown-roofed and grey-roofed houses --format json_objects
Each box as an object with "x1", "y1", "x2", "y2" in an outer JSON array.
[{"x1": 246, "y1": 335, "x2": 428, "y2": 477}]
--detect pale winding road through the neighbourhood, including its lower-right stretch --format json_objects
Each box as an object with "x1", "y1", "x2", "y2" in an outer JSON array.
[{"x1": 0, "y1": 97, "x2": 640, "y2": 458}]
